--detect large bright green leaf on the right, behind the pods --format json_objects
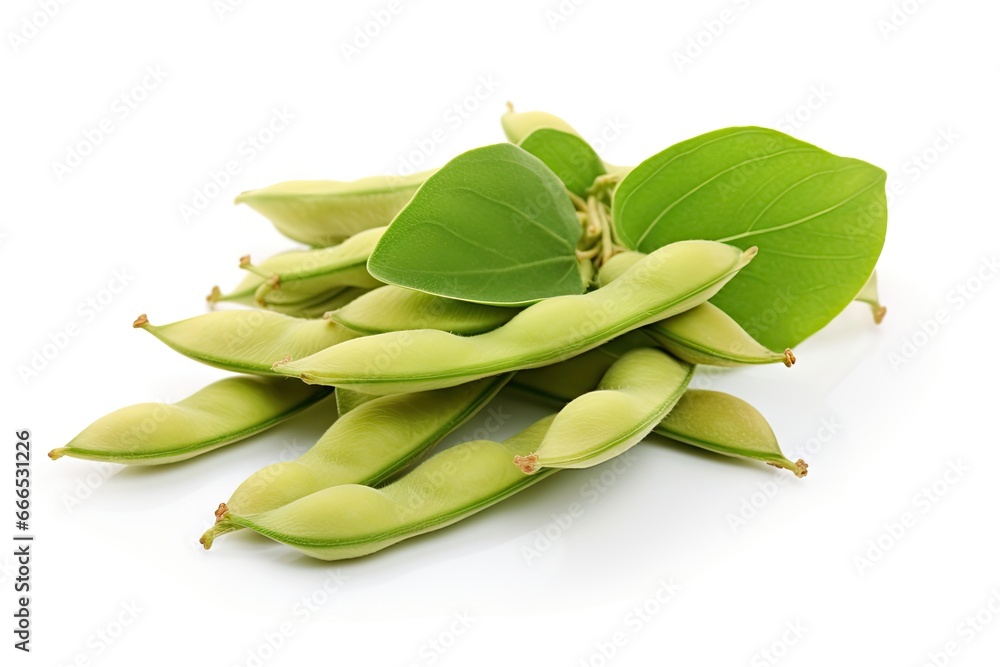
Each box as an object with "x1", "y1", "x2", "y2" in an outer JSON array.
[{"x1": 613, "y1": 127, "x2": 886, "y2": 349}]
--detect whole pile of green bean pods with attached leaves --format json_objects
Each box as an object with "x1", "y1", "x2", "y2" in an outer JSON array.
[{"x1": 50, "y1": 108, "x2": 885, "y2": 560}]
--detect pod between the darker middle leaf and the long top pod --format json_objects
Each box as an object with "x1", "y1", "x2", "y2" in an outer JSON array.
[{"x1": 329, "y1": 285, "x2": 519, "y2": 335}]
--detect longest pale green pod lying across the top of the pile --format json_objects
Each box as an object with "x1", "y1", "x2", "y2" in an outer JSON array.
[{"x1": 275, "y1": 241, "x2": 756, "y2": 394}]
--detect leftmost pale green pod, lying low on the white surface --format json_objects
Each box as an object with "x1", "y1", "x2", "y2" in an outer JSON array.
[{"x1": 49, "y1": 377, "x2": 330, "y2": 465}]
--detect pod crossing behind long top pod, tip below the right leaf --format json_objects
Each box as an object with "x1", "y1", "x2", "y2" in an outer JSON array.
[{"x1": 598, "y1": 252, "x2": 795, "y2": 368}]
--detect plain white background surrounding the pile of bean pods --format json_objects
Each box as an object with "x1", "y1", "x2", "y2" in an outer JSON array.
[{"x1": 0, "y1": 0, "x2": 1000, "y2": 667}]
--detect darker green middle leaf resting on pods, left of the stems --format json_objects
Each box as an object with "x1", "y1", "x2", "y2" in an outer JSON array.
[{"x1": 368, "y1": 144, "x2": 586, "y2": 306}]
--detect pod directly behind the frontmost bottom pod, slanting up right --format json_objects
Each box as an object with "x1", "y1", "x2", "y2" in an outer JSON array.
[{"x1": 202, "y1": 373, "x2": 511, "y2": 543}]
